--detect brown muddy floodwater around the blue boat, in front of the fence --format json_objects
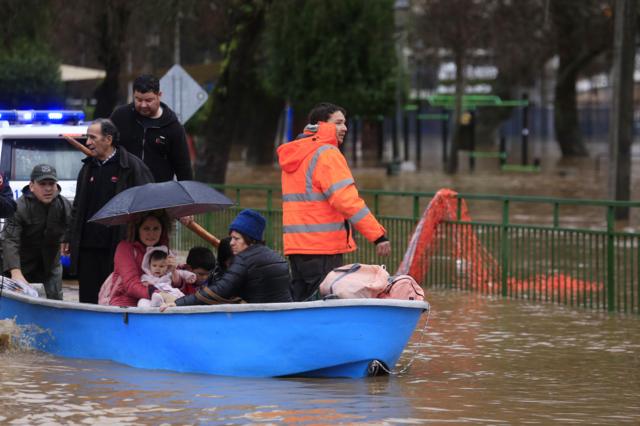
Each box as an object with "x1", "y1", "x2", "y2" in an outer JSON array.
[{"x1": 0, "y1": 292, "x2": 640, "y2": 424}]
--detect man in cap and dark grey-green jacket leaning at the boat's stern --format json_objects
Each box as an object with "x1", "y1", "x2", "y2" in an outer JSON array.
[{"x1": 0, "y1": 164, "x2": 71, "y2": 300}]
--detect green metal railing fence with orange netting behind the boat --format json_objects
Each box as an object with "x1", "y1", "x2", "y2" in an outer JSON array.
[{"x1": 176, "y1": 185, "x2": 640, "y2": 314}]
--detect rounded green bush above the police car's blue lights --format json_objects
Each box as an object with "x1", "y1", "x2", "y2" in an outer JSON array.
[{"x1": 0, "y1": 40, "x2": 62, "y2": 108}]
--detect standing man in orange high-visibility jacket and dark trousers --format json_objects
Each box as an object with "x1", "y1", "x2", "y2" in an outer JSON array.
[{"x1": 278, "y1": 103, "x2": 391, "y2": 301}]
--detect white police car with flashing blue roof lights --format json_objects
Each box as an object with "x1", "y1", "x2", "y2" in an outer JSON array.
[{"x1": 0, "y1": 110, "x2": 88, "y2": 201}]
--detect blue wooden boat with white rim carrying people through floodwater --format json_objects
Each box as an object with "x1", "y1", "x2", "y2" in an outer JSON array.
[{"x1": 0, "y1": 289, "x2": 429, "y2": 377}]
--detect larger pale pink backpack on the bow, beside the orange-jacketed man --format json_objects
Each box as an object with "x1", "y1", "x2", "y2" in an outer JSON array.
[{"x1": 320, "y1": 263, "x2": 389, "y2": 299}]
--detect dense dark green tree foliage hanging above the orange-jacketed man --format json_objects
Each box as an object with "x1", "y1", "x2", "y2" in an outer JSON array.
[{"x1": 263, "y1": 0, "x2": 397, "y2": 116}]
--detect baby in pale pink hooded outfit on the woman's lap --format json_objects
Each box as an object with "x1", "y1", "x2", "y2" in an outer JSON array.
[{"x1": 138, "y1": 246, "x2": 196, "y2": 308}]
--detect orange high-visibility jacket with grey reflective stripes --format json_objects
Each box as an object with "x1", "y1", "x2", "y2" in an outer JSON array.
[{"x1": 278, "y1": 122, "x2": 386, "y2": 255}]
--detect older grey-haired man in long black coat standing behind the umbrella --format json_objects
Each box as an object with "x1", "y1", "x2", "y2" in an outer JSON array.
[{"x1": 62, "y1": 118, "x2": 153, "y2": 303}]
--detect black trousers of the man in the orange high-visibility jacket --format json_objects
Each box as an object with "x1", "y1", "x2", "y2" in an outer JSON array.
[{"x1": 289, "y1": 254, "x2": 342, "y2": 302}]
